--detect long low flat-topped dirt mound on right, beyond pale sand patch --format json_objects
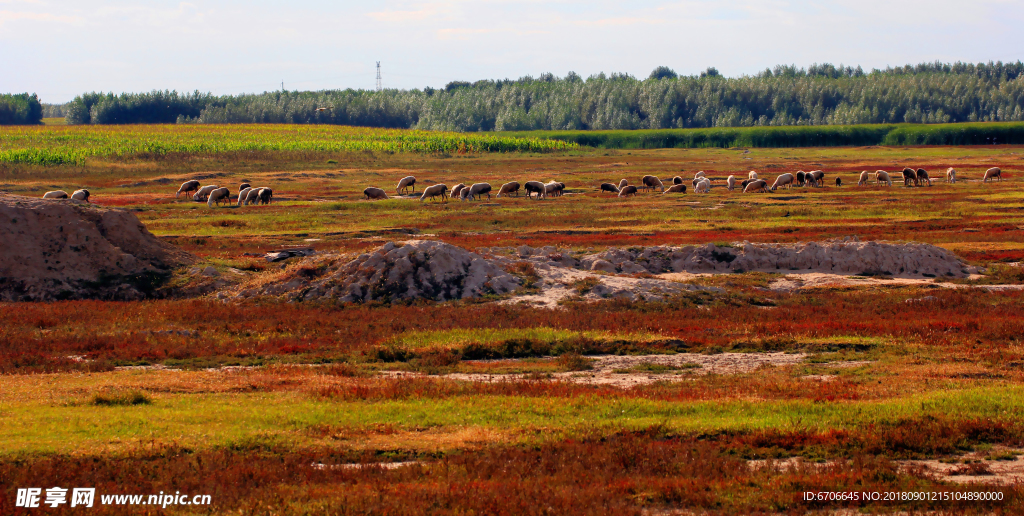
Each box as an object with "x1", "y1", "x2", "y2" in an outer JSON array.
[{"x1": 580, "y1": 239, "x2": 969, "y2": 277}]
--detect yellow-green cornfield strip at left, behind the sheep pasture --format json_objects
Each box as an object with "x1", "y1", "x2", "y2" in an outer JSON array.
[{"x1": 0, "y1": 124, "x2": 579, "y2": 165}]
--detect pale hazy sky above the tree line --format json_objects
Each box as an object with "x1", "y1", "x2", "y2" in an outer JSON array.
[{"x1": 0, "y1": 0, "x2": 1024, "y2": 103}]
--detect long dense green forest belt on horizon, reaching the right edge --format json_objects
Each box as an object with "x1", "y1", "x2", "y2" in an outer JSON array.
[{"x1": 46, "y1": 61, "x2": 1024, "y2": 131}]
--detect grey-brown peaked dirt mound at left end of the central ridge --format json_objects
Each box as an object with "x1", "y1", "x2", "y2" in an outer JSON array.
[{"x1": 238, "y1": 241, "x2": 520, "y2": 302}]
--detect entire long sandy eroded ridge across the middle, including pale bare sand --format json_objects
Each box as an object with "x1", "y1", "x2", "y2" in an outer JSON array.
[{"x1": 230, "y1": 240, "x2": 967, "y2": 307}]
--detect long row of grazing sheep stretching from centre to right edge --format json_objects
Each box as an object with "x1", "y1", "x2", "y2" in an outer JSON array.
[{"x1": 362, "y1": 167, "x2": 1002, "y2": 202}]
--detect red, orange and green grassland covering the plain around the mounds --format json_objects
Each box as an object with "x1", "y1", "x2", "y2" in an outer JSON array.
[{"x1": 0, "y1": 127, "x2": 1024, "y2": 514}]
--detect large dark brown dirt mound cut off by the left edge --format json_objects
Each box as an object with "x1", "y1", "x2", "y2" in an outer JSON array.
[{"x1": 0, "y1": 194, "x2": 193, "y2": 301}]
